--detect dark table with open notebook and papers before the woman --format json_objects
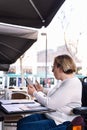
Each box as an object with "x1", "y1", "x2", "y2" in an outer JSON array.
[{"x1": 0, "y1": 100, "x2": 54, "y2": 130}]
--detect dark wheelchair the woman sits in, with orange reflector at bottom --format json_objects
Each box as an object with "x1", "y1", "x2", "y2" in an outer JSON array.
[{"x1": 67, "y1": 76, "x2": 87, "y2": 130}]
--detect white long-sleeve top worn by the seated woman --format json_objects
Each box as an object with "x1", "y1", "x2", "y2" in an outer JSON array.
[{"x1": 34, "y1": 77, "x2": 82, "y2": 124}]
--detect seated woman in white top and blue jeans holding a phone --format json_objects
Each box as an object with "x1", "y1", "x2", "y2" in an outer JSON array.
[{"x1": 17, "y1": 55, "x2": 82, "y2": 130}]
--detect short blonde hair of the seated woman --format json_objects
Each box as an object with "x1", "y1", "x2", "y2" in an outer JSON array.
[{"x1": 54, "y1": 54, "x2": 77, "y2": 74}]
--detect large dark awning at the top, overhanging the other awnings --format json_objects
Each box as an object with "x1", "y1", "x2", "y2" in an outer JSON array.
[{"x1": 0, "y1": 0, "x2": 65, "y2": 28}]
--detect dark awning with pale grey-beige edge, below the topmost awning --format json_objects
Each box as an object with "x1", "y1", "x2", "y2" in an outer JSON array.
[{"x1": 0, "y1": 24, "x2": 38, "y2": 64}]
